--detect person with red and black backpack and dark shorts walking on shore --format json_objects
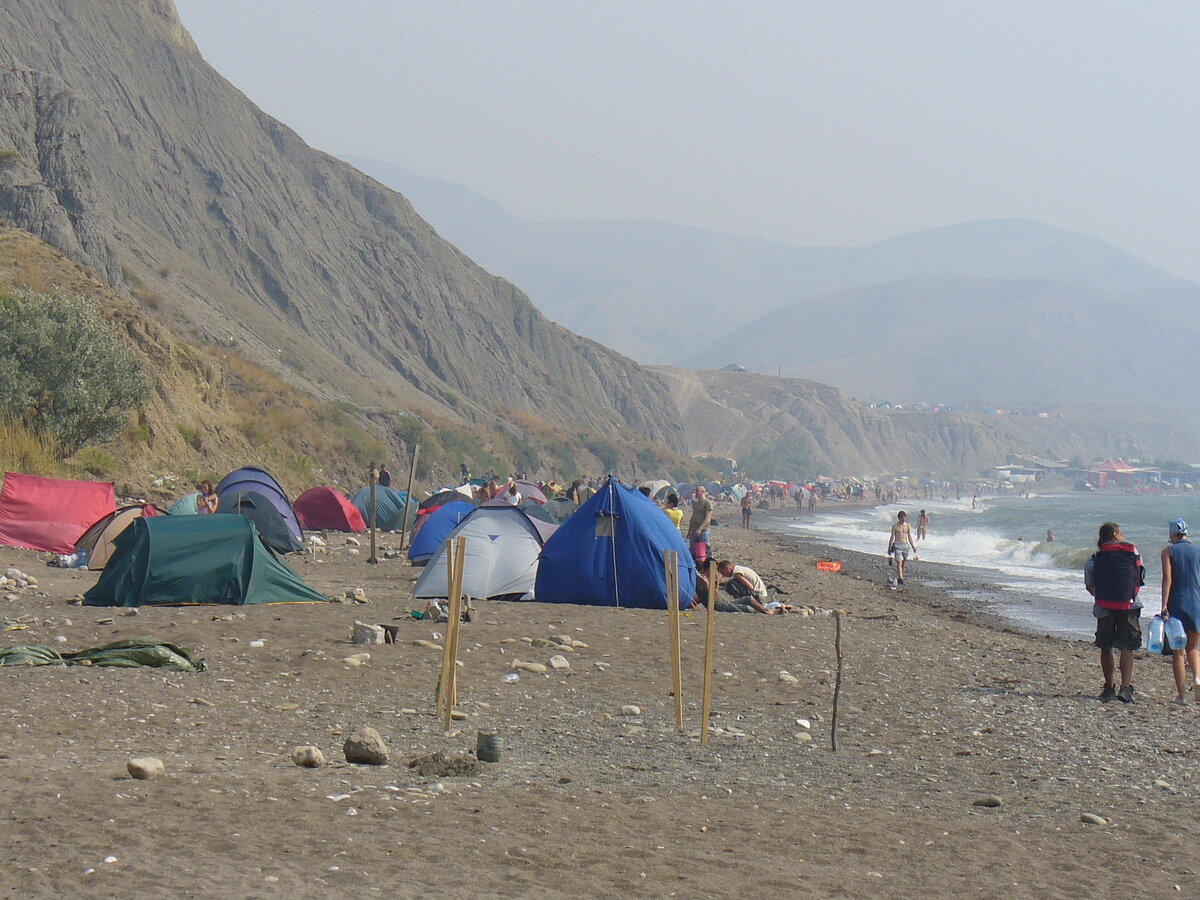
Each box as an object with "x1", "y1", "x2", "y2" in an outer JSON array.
[{"x1": 1084, "y1": 522, "x2": 1146, "y2": 703}]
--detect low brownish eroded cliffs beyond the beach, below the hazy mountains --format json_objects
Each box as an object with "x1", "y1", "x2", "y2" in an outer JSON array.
[{"x1": 654, "y1": 366, "x2": 1200, "y2": 476}]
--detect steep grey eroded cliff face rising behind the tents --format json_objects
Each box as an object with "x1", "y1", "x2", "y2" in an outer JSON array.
[{"x1": 0, "y1": 0, "x2": 680, "y2": 444}]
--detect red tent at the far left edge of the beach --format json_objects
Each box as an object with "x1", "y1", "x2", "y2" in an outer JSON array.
[{"x1": 0, "y1": 472, "x2": 116, "y2": 553}]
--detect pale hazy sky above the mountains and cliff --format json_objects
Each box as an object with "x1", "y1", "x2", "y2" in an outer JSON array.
[{"x1": 176, "y1": 0, "x2": 1200, "y2": 280}]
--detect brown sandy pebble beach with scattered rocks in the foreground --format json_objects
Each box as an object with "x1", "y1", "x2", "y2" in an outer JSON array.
[{"x1": 0, "y1": 506, "x2": 1200, "y2": 898}]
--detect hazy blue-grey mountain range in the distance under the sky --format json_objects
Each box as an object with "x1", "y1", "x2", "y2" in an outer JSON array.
[{"x1": 347, "y1": 156, "x2": 1195, "y2": 381}]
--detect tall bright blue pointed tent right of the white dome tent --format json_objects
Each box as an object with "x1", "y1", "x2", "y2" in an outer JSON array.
[{"x1": 534, "y1": 476, "x2": 696, "y2": 610}]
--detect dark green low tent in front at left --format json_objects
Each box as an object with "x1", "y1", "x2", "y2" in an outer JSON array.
[{"x1": 84, "y1": 516, "x2": 326, "y2": 606}]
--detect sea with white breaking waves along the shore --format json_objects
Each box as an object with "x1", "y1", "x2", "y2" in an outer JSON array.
[{"x1": 788, "y1": 492, "x2": 1200, "y2": 638}]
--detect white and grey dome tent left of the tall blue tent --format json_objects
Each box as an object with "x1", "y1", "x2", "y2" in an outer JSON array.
[{"x1": 413, "y1": 500, "x2": 558, "y2": 600}]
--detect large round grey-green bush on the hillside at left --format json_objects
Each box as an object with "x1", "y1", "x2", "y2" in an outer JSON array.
[{"x1": 0, "y1": 290, "x2": 150, "y2": 456}]
